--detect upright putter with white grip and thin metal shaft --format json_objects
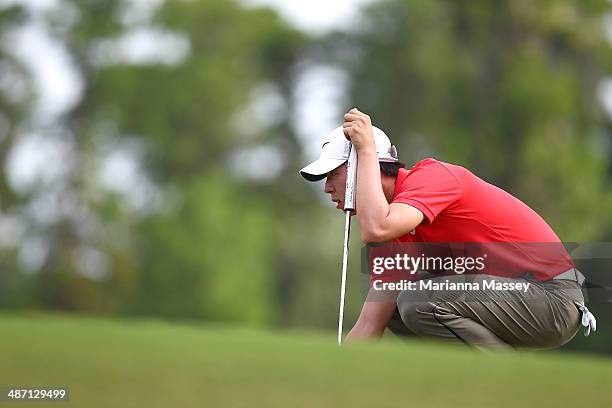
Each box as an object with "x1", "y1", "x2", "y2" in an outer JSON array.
[{"x1": 338, "y1": 142, "x2": 357, "y2": 346}]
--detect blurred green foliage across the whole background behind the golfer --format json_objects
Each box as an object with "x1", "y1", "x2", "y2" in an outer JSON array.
[{"x1": 0, "y1": 0, "x2": 612, "y2": 351}]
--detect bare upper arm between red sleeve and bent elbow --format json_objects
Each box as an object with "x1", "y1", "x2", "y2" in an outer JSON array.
[{"x1": 362, "y1": 203, "x2": 424, "y2": 242}]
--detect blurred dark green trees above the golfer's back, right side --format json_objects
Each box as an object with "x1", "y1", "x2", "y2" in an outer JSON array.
[{"x1": 323, "y1": 0, "x2": 612, "y2": 241}]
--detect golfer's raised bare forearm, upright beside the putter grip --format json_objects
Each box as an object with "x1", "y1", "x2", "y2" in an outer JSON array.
[{"x1": 356, "y1": 148, "x2": 389, "y2": 242}]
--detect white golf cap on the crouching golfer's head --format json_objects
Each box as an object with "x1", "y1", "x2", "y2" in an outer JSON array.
[{"x1": 300, "y1": 126, "x2": 398, "y2": 181}]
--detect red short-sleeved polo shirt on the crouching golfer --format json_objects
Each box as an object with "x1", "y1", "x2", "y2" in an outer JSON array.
[{"x1": 376, "y1": 158, "x2": 574, "y2": 280}]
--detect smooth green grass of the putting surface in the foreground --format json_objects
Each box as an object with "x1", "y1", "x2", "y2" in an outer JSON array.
[{"x1": 0, "y1": 315, "x2": 612, "y2": 408}]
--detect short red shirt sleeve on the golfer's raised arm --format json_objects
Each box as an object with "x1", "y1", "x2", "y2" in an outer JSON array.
[{"x1": 393, "y1": 159, "x2": 462, "y2": 224}]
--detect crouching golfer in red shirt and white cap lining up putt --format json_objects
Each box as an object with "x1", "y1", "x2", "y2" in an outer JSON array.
[{"x1": 300, "y1": 108, "x2": 595, "y2": 349}]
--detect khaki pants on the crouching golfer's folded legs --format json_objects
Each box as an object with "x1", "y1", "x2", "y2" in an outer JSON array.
[{"x1": 387, "y1": 275, "x2": 584, "y2": 349}]
